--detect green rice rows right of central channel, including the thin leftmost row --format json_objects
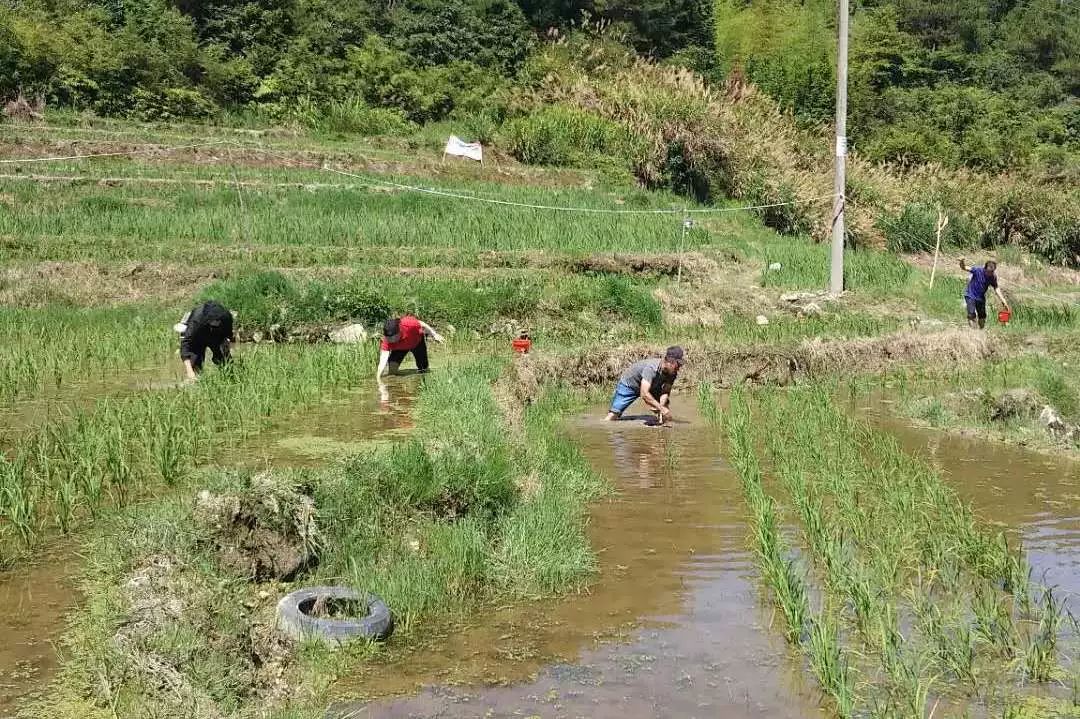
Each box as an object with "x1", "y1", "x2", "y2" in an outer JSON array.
[{"x1": 725, "y1": 385, "x2": 1080, "y2": 716}]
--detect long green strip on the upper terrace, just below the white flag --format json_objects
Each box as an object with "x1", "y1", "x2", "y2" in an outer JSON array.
[{"x1": 0, "y1": 161, "x2": 734, "y2": 259}]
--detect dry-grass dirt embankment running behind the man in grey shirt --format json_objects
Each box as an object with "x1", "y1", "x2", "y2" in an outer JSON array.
[{"x1": 497, "y1": 329, "x2": 1002, "y2": 420}]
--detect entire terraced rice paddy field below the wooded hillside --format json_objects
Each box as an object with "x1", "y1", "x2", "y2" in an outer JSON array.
[{"x1": 0, "y1": 117, "x2": 1080, "y2": 718}]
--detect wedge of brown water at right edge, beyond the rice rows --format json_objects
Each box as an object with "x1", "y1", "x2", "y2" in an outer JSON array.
[{"x1": 853, "y1": 398, "x2": 1080, "y2": 600}]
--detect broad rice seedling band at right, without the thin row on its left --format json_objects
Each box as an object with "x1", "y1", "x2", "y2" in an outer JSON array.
[{"x1": 733, "y1": 386, "x2": 1080, "y2": 716}]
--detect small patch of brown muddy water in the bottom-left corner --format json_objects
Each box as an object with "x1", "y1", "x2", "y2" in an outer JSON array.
[{"x1": 0, "y1": 550, "x2": 76, "y2": 718}]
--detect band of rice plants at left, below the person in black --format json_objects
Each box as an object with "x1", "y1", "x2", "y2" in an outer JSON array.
[{"x1": 0, "y1": 338, "x2": 375, "y2": 565}]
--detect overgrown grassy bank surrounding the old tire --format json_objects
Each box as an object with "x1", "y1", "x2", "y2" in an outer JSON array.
[{"x1": 42, "y1": 361, "x2": 604, "y2": 716}]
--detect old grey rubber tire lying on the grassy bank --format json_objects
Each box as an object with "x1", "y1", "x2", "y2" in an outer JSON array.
[{"x1": 278, "y1": 586, "x2": 394, "y2": 646}]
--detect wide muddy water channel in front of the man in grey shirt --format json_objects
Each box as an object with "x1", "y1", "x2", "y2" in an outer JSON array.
[{"x1": 329, "y1": 399, "x2": 818, "y2": 719}]
